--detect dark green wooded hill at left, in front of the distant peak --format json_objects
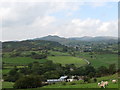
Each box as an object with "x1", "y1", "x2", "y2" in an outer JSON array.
[{"x1": 2, "y1": 40, "x2": 64, "y2": 51}]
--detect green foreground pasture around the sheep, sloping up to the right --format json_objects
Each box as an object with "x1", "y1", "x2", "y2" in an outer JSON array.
[{"x1": 42, "y1": 74, "x2": 118, "y2": 88}]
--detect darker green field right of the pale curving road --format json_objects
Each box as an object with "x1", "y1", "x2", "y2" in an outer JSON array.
[{"x1": 78, "y1": 53, "x2": 118, "y2": 68}]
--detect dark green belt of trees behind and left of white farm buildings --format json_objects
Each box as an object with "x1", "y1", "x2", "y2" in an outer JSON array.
[{"x1": 3, "y1": 61, "x2": 117, "y2": 88}]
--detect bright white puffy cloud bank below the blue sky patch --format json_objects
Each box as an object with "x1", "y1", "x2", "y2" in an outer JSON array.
[{"x1": 54, "y1": 18, "x2": 118, "y2": 37}]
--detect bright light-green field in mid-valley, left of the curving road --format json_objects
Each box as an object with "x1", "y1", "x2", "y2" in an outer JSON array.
[{"x1": 48, "y1": 56, "x2": 87, "y2": 66}]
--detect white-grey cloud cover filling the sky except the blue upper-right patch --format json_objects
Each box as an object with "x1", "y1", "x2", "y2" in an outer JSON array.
[{"x1": 0, "y1": 2, "x2": 118, "y2": 41}]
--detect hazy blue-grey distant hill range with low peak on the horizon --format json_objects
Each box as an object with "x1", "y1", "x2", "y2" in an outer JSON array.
[{"x1": 33, "y1": 35, "x2": 117, "y2": 45}]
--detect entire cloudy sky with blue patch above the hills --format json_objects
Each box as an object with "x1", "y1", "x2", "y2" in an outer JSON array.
[{"x1": 0, "y1": 1, "x2": 118, "y2": 41}]
